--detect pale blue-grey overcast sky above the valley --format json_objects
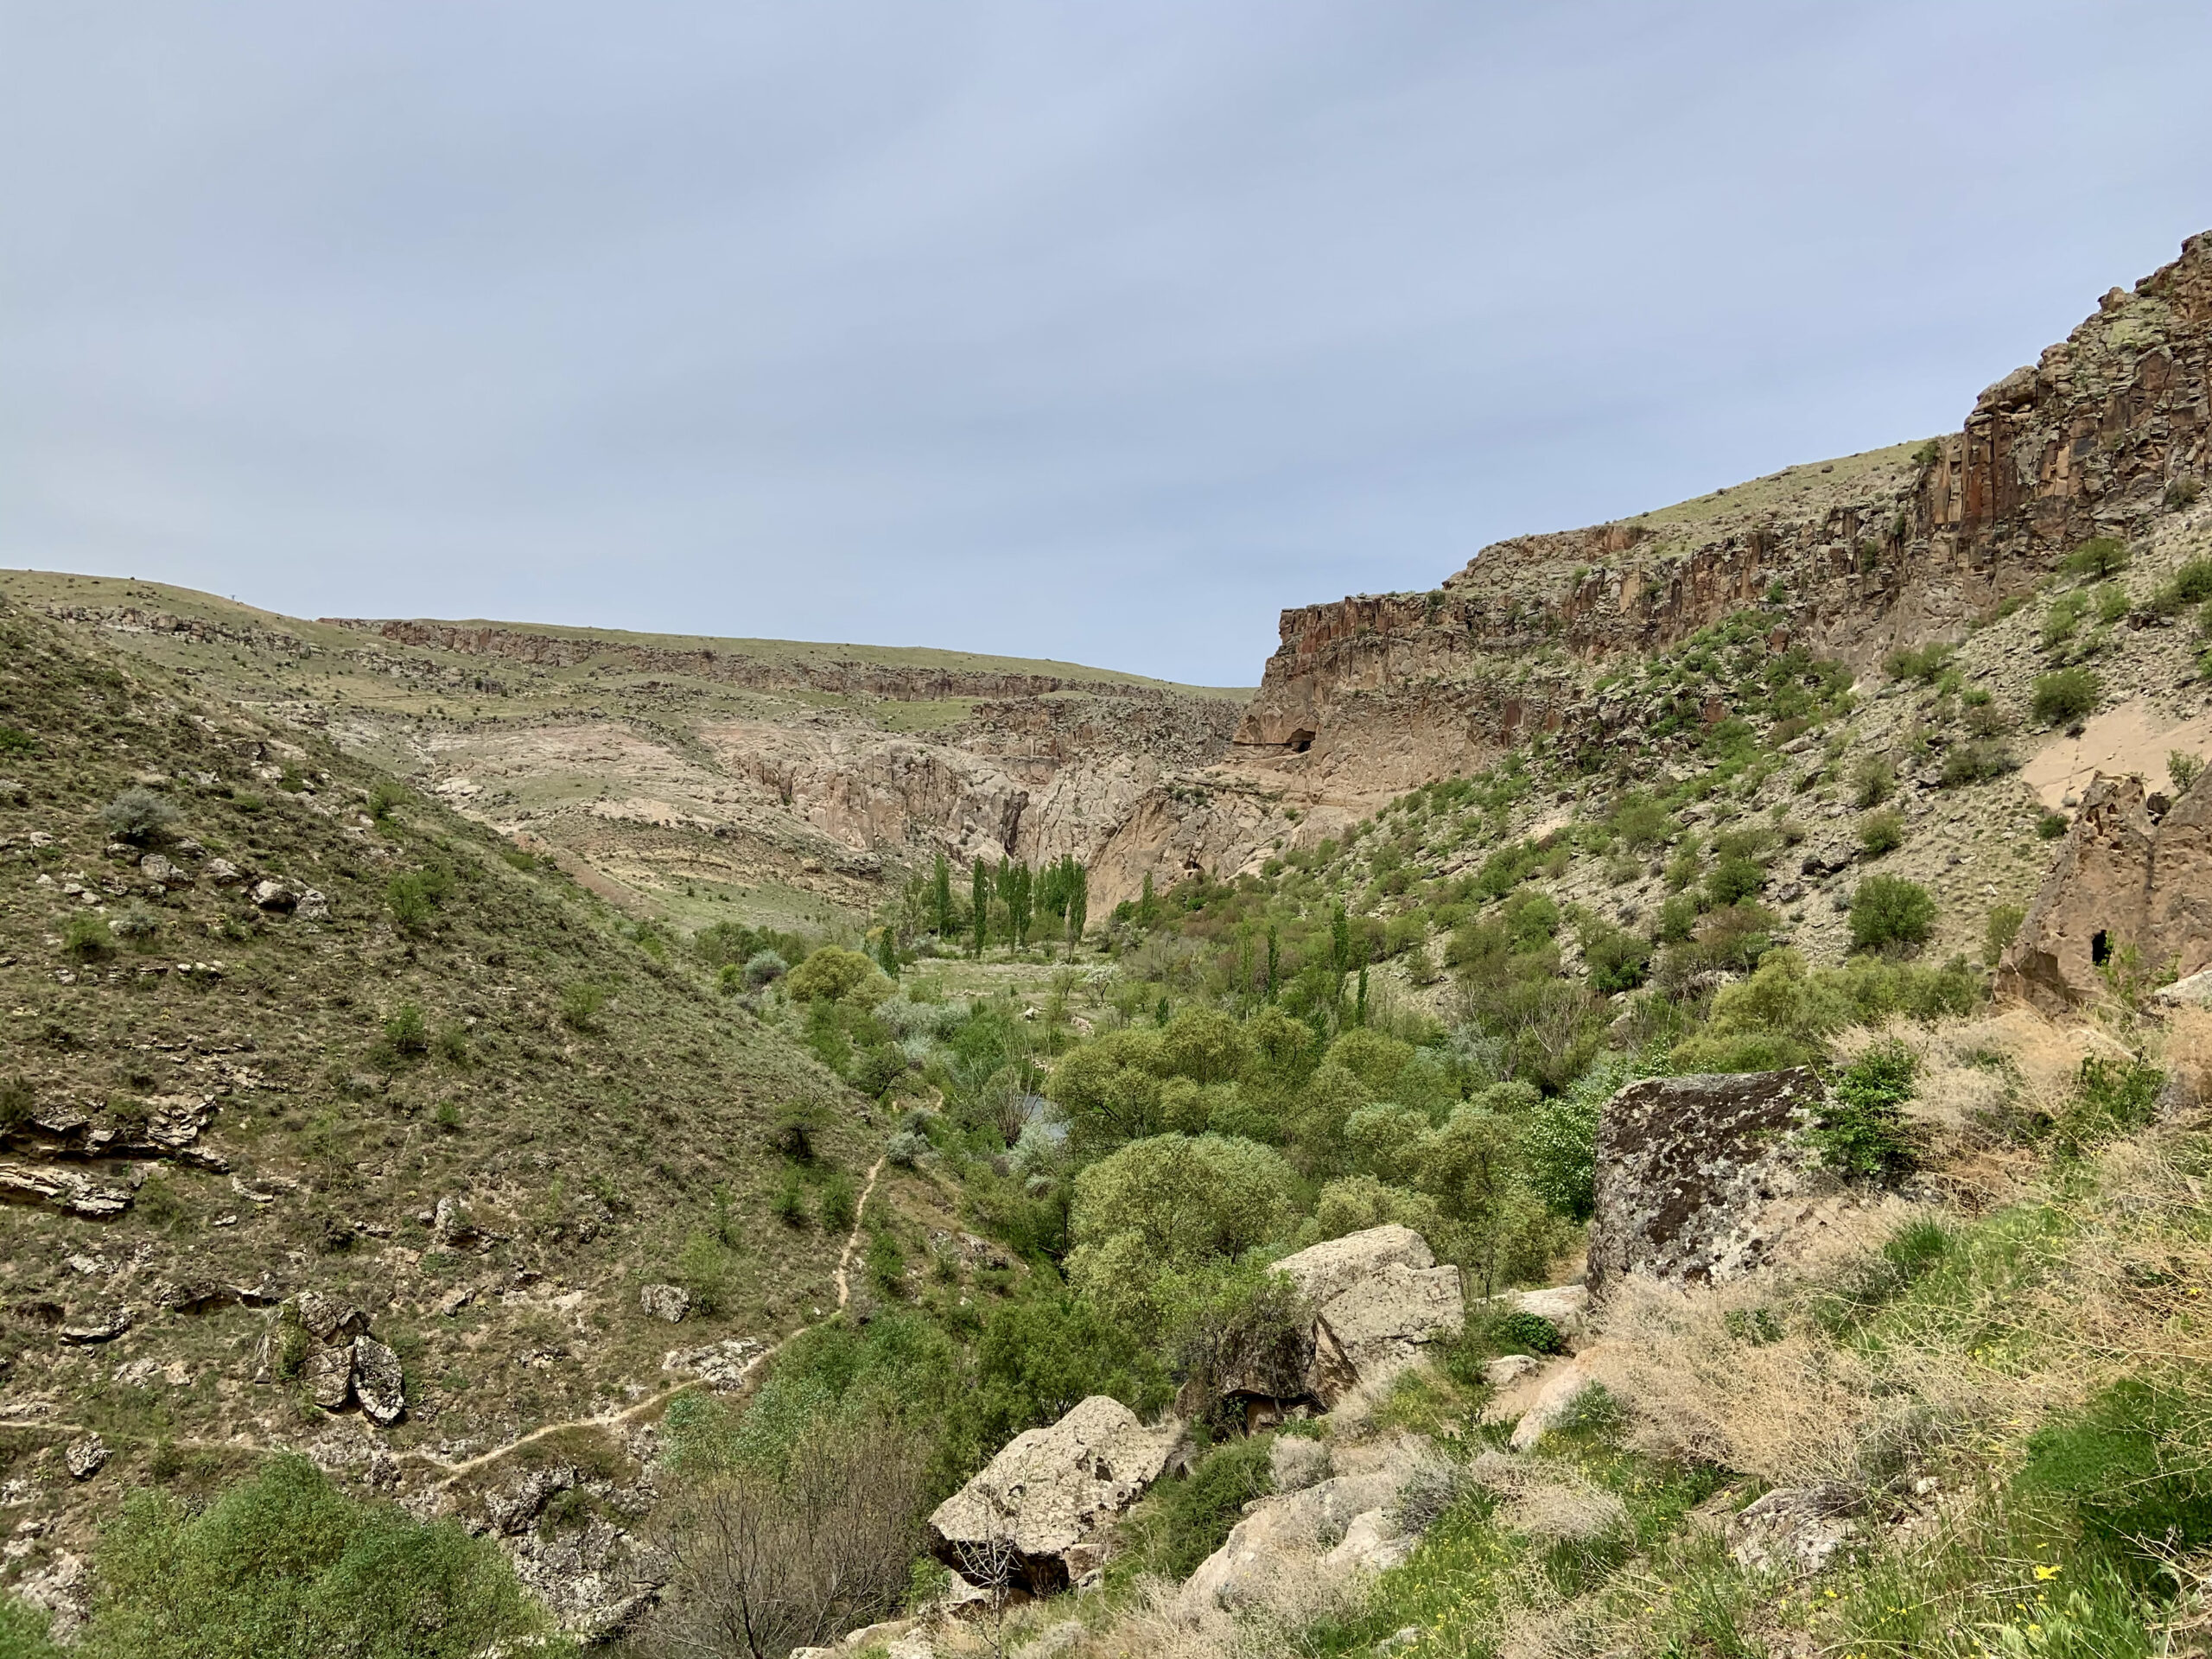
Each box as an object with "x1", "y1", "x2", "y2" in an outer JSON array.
[{"x1": 0, "y1": 0, "x2": 2212, "y2": 683}]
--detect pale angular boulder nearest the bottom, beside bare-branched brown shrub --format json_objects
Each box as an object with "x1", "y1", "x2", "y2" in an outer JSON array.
[{"x1": 929, "y1": 1394, "x2": 1184, "y2": 1595}]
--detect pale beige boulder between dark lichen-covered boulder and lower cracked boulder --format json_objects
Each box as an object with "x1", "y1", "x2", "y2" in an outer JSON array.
[{"x1": 1276, "y1": 1225, "x2": 1466, "y2": 1405}]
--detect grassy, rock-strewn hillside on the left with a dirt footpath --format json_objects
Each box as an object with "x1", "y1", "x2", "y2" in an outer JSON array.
[{"x1": 0, "y1": 601, "x2": 882, "y2": 1628}]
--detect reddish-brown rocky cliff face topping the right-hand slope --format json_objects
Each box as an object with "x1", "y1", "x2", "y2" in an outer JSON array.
[{"x1": 1236, "y1": 232, "x2": 2212, "y2": 794}]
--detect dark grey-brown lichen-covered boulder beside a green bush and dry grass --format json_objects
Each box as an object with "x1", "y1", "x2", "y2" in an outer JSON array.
[{"x1": 1586, "y1": 1066, "x2": 1822, "y2": 1296}]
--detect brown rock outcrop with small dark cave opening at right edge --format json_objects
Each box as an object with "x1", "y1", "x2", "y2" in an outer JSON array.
[{"x1": 1998, "y1": 777, "x2": 2212, "y2": 1013}]
